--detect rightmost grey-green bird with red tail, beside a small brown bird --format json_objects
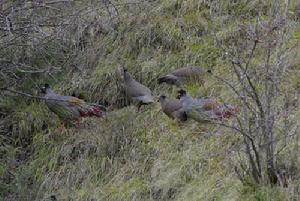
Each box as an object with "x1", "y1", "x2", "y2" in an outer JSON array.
[{"x1": 177, "y1": 89, "x2": 239, "y2": 122}]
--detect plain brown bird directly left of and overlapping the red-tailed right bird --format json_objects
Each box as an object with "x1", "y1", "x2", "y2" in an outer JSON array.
[{"x1": 159, "y1": 95, "x2": 187, "y2": 121}]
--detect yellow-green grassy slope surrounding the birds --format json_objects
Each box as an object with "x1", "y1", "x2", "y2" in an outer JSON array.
[{"x1": 1, "y1": 1, "x2": 300, "y2": 200}]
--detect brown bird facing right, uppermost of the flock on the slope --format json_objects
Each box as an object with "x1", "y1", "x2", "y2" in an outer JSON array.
[{"x1": 157, "y1": 67, "x2": 205, "y2": 86}]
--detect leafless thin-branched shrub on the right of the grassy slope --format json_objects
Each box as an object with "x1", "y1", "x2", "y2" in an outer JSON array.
[{"x1": 211, "y1": 1, "x2": 299, "y2": 187}]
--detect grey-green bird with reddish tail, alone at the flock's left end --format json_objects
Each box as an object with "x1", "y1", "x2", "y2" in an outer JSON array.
[{"x1": 41, "y1": 83, "x2": 106, "y2": 122}]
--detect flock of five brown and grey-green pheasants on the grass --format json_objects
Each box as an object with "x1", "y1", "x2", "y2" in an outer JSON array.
[{"x1": 42, "y1": 67, "x2": 239, "y2": 126}]
